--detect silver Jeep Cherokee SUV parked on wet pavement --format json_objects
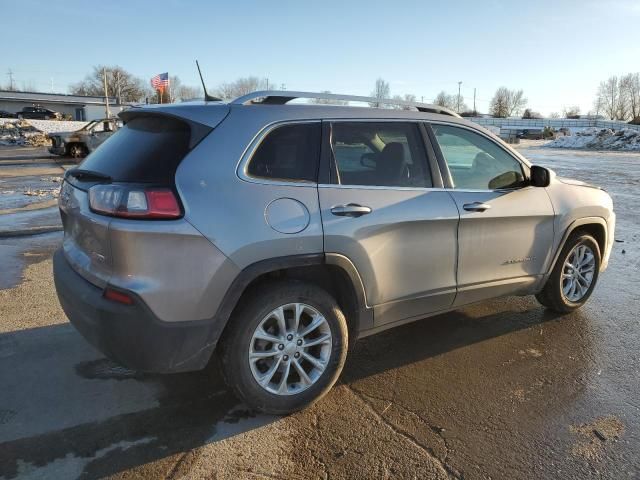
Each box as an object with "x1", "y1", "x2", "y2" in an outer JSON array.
[{"x1": 54, "y1": 91, "x2": 615, "y2": 413}]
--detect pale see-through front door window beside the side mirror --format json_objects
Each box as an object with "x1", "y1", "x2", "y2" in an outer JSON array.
[{"x1": 432, "y1": 125, "x2": 524, "y2": 190}]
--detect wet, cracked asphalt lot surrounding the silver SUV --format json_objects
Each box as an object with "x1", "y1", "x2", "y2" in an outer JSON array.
[{"x1": 0, "y1": 147, "x2": 640, "y2": 479}]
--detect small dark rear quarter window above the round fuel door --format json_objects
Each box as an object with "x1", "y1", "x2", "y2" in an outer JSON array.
[{"x1": 247, "y1": 122, "x2": 321, "y2": 182}]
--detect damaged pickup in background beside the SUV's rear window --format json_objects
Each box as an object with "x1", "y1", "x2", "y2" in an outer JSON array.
[{"x1": 47, "y1": 118, "x2": 122, "y2": 158}]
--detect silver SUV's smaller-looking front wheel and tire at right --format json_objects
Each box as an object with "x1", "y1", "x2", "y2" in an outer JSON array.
[{"x1": 536, "y1": 232, "x2": 601, "y2": 313}]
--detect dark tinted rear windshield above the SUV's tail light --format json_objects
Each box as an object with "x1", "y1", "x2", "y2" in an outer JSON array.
[{"x1": 80, "y1": 116, "x2": 191, "y2": 185}]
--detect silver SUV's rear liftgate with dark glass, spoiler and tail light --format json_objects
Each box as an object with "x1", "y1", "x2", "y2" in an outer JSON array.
[{"x1": 59, "y1": 105, "x2": 227, "y2": 287}]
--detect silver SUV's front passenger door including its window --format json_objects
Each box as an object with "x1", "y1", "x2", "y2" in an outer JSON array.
[{"x1": 431, "y1": 123, "x2": 554, "y2": 306}]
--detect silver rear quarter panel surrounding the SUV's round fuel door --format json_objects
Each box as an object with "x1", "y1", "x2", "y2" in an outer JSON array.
[{"x1": 176, "y1": 107, "x2": 323, "y2": 269}]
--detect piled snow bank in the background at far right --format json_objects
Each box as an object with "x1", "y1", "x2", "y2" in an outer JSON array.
[{"x1": 545, "y1": 128, "x2": 640, "y2": 151}]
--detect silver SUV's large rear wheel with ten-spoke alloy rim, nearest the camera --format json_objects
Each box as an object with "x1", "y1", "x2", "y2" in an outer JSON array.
[{"x1": 220, "y1": 281, "x2": 349, "y2": 415}]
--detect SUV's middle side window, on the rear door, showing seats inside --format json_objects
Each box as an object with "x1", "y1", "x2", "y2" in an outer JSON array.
[{"x1": 331, "y1": 122, "x2": 432, "y2": 187}]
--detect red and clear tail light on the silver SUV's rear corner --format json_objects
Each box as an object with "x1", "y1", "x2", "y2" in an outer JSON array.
[{"x1": 89, "y1": 185, "x2": 182, "y2": 219}]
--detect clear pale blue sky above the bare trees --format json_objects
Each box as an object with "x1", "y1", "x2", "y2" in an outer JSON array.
[{"x1": 0, "y1": 0, "x2": 640, "y2": 114}]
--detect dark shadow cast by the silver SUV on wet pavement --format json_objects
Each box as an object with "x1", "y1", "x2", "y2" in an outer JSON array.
[{"x1": 0, "y1": 300, "x2": 558, "y2": 479}]
